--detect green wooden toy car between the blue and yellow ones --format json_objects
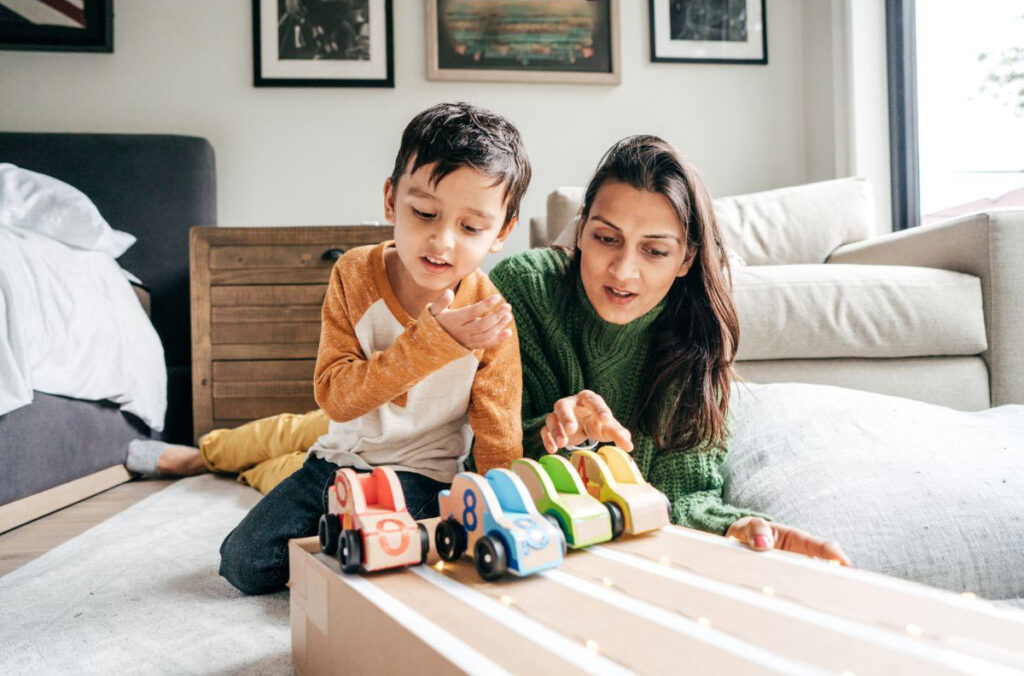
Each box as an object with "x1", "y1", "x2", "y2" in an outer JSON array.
[{"x1": 512, "y1": 455, "x2": 625, "y2": 549}]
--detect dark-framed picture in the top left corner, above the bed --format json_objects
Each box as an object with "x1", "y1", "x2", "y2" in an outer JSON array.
[{"x1": 0, "y1": 0, "x2": 114, "y2": 52}]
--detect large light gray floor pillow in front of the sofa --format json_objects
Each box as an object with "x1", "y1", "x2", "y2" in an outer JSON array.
[{"x1": 723, "y1": 383, "x2": 1024, "y2": 599}]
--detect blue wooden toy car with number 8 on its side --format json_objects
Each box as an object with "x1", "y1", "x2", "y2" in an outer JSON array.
[{"x1": 434, "y1": 469, "x2": 565, "y2": 581}]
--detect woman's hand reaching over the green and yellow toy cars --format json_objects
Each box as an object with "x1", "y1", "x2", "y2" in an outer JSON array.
[{"x1": 541, "y1": 389, "x2": 633, "y2": 453}]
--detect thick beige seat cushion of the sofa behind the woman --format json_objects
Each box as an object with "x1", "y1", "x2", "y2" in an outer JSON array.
[{"x1": 732, "y1": 264, "x2": 986, "y2": 360}]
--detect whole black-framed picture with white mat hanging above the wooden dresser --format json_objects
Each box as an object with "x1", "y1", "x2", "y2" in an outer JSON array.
[{"x1": 253, "y1": 0, "x2": 394, "y2": 87}]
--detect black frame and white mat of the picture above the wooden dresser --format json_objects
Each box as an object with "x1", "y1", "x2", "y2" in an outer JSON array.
[{"x1": 252, "y1": 0, "x2": 394, "y2": 88}]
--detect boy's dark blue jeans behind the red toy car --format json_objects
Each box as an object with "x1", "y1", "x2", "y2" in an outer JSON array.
[{"x1": 220, "y1": 456, "x2": 449, "y2": 594}]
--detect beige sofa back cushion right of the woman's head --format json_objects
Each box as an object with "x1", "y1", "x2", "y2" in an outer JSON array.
[{"x1": 715, "y1": 178, "x2": 874, "y2": 265}]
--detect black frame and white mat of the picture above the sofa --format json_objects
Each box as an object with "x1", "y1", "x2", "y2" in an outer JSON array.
[{"x1": 648, "y1": 0, "x2": 768, "y2": 66}]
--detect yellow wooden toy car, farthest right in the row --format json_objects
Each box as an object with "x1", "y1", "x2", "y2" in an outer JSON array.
[{"x1": 570, "y1": 446, "x2": 670, "y2": 535}]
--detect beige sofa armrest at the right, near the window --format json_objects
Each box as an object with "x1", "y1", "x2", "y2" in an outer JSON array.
[{"x1": 827, "y1": 210, "x2": 1024, "y2": 406}]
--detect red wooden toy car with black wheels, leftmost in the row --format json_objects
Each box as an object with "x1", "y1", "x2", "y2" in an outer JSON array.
[{"x1": 319, "y1": 467, "x2": 430, "y2": 573}]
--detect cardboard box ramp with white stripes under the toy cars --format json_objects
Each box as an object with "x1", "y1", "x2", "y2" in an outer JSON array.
[{"x1": 290, "y1": 523, "x2": 1024, "y2": 674}]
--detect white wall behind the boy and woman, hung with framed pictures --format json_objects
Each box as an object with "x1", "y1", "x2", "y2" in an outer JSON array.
[{"x1": 0, "y1": 0, "x2": 834, "y2": 259}]
